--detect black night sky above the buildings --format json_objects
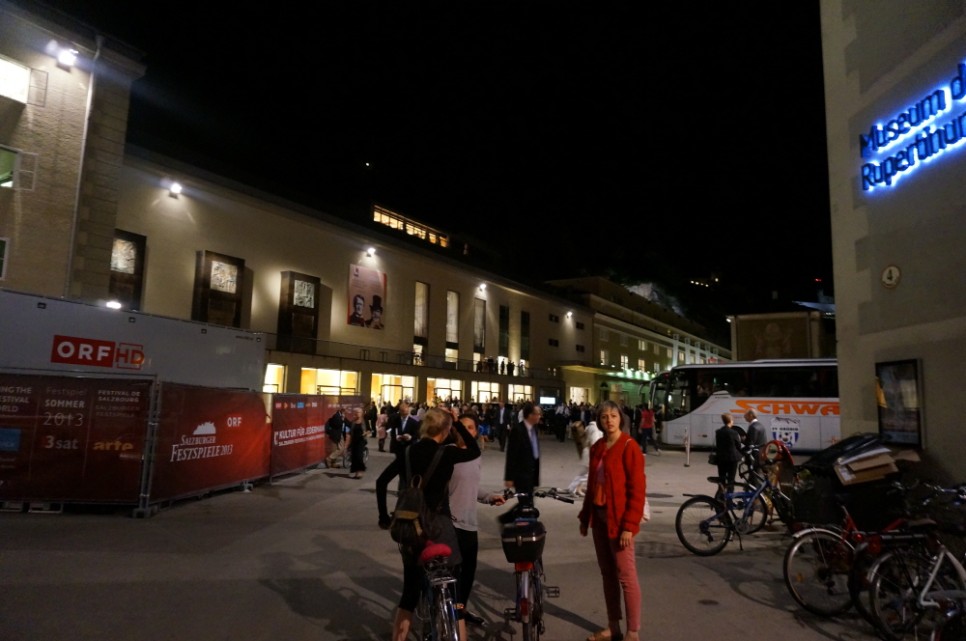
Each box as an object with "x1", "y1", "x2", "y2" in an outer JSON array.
[{"x1": 37, "y1": 0, "x2": 831, "y2": 313}]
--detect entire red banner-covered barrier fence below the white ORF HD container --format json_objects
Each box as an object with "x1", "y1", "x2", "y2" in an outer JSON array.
[{"x1": 0, "y1": 373, "x2": 361, "y2": 511}]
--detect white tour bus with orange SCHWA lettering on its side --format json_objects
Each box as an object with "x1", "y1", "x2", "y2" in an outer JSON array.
[{"x1": 650, "y1": 359, "x2": 840, "y2": 452}]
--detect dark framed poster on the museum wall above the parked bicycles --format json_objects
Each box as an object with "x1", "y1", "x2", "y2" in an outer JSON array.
[{"x1": 875, "y1": 359, "x2": 922, "y2": 447}]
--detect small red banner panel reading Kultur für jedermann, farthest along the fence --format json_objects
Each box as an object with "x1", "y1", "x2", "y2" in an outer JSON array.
[{"x1": 271, "y1": 394, "x2": 334, "y2": 475}]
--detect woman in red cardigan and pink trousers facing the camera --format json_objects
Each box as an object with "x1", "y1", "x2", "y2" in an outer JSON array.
[{"x1": 578, "y1": 401, "x2": 647, "y2": 641}]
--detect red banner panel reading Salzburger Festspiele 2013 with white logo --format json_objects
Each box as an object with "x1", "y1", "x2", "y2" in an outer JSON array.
[{"x1": 150, "y1": 383, "x2": 271, "y2": 503}]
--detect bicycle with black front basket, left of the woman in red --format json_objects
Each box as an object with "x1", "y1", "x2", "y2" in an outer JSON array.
[{"x1": 502, "y1": 488, "x2": 574, "y2": 641}]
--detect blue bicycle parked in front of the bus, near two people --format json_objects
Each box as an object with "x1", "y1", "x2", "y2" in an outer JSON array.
[{"x1": 674, "y1": 460, "x2": 794, "y2": 556}]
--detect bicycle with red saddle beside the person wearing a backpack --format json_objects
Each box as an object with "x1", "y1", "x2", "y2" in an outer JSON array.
[{"x1": 413, "y1": 542, "x2": 459, "y2": 641}]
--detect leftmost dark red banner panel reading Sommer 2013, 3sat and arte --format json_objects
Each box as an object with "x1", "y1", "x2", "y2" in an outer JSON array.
[{"x1": 0, "y1": 374, "x2": 152, "y2": 503}]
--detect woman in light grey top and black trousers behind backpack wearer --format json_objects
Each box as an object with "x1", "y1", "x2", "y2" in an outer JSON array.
[{"x1": 449, "y1": 413, "x2": 505, "y2": 627}]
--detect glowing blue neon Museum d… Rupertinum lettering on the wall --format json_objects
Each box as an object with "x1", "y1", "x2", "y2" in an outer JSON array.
[{"x1": 859, "y1": 63, "x2": 966, "y2": 191}]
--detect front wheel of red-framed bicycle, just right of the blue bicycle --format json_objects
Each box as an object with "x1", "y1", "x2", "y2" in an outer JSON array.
[{"x1": 782, "y1": 529, "x2": 855, "y2": 617}]
